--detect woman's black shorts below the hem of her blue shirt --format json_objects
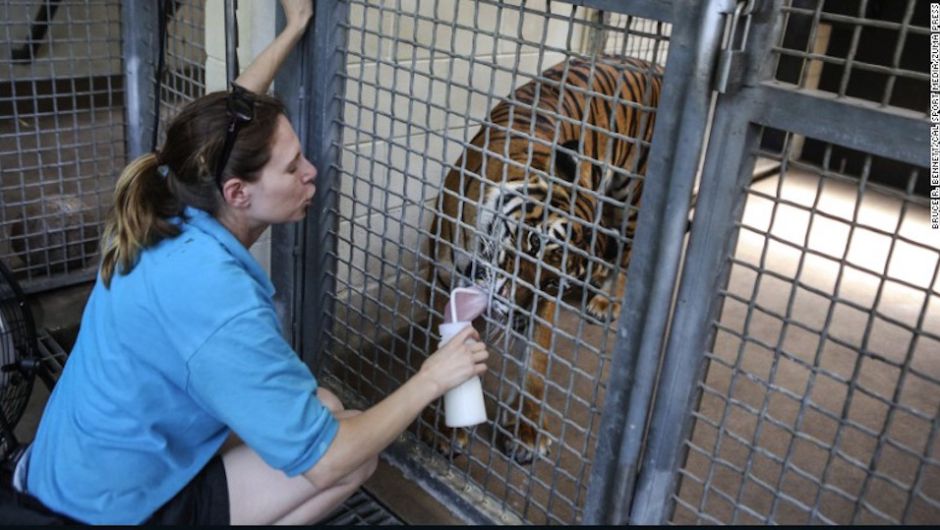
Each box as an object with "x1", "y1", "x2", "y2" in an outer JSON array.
[{"x1": 149, "y1": 455, "x2": 235, "y2": 526}]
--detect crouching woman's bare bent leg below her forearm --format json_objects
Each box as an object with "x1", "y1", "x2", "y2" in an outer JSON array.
[{"x1": 222, "y1": 389, "x2": 378, "y2": 525}]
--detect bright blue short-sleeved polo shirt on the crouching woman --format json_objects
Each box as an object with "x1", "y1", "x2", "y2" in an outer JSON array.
[{"x1": 27, "y1": 208, "x2": 338, "y2": 524}]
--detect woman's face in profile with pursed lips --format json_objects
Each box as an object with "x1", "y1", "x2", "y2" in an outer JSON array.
[{"x1": 248, "y1": 116, "x2": 317, "y2": 224}]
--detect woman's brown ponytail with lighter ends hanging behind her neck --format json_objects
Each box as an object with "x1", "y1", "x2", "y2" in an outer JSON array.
[{"x1": 101, "y1": 153, "x2": 182, "y2": 288}]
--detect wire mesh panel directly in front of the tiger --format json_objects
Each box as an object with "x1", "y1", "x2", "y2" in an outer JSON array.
[{"x1": 318, "y1": 0, "x2": 669, "y2": 523}]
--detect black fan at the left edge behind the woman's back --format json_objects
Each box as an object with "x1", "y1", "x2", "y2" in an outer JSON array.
[{"x1": 0, "y1": 262, "x2": 46, "y2": 458}]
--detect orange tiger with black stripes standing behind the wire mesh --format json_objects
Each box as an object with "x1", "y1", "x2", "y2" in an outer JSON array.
[{"x1": 429, "y1": 55, "x2": 663, "y2": 463}]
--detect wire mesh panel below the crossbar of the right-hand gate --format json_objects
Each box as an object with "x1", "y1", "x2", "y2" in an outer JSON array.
[{"x1": 675, "y1": 130, "x2": 940, "y2": 524}]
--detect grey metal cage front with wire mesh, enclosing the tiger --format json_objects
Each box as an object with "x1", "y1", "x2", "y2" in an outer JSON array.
[{"x1": 272, "y1": 0, "x2": 940, "y2": 524}]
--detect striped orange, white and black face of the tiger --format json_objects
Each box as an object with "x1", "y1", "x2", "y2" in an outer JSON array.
[{"x1": 458, "y1": 145, "x2": 608, "y2": 329}]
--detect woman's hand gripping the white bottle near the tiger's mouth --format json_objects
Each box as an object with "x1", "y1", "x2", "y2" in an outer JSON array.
[{"x1": 418, "y1": 326, "x2": 490, "y2": 397}]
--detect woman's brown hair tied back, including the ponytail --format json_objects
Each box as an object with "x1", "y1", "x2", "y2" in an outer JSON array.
[{"x1": 101, "y1": 92, "x2": 286, "y2": 288}]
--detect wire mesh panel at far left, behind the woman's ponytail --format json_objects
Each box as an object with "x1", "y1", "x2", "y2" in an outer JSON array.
[{"x1": 0, "y1": 0, "x2": 124, "y2": 290}]
